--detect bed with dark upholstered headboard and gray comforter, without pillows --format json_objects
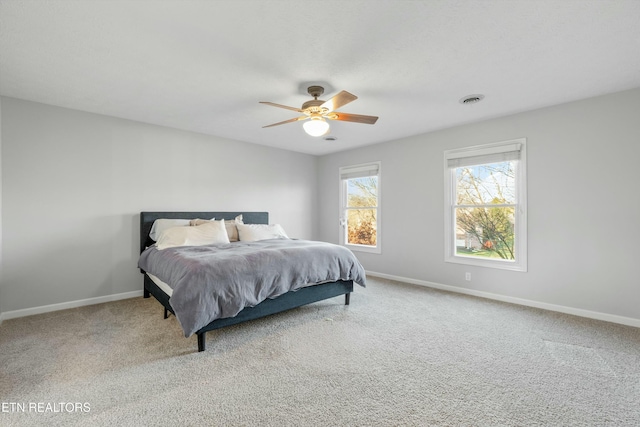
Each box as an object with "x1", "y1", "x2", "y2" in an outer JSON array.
[{"x1": 138, "y1": 212, "x2": 366, "y2": 351}]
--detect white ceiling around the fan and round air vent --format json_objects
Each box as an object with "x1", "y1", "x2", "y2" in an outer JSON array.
[{"x1": 0, "y1": 0, "x2": 640, "y2": 155}]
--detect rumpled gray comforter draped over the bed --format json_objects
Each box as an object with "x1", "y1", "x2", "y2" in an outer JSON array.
[{"x1": 138, "y1": 239, "x2": 366, "y2": 337}]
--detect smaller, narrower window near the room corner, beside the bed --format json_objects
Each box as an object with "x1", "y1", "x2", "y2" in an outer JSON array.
[{"x1": 340, "y1": 162, "x2": 380, "y2": 253}]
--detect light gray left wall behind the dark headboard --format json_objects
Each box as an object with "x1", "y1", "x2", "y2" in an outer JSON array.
[{"x1": 0, "y1": 97, "x2": 317, "y2": 312}]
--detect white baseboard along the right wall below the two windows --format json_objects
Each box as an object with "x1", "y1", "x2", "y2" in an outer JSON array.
[{"x1": 367, "y1": 271, "x2": 640, "y2": 328}]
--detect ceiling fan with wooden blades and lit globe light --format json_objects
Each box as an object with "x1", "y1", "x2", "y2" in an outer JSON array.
[{"x1": 260, "y1": 86, "x2": 378, "y2": 136}]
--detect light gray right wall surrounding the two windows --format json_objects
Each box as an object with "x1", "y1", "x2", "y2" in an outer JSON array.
[{"x1": 318, "y1": 89, "x2": 640, "y2": 319}]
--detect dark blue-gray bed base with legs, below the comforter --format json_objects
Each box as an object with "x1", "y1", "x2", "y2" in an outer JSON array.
[{"x1": 144, "y1": 274, "x2": 353, "y2": 351}]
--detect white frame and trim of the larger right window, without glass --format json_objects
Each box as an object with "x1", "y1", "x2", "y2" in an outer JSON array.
[{"x1": 444, "y1": 138, "x2": 527, "y2": 271}]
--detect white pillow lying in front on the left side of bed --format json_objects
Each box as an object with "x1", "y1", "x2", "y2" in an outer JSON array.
[{"x1": 156, "y1": 220, "x2": 229, "y2": 250}]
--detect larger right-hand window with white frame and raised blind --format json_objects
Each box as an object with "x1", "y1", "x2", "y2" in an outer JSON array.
[{"x1": 445, "y1": 139, "x2": 527, "y2": 271}]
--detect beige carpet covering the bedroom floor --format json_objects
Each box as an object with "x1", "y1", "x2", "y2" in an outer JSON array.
[{"x1": 0, "y1": 278, "x2": 640, "y2": 426}]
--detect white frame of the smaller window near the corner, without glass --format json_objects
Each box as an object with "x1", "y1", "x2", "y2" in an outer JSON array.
[{"x1": 338, "y1": 161, "x2": 382, "y2": 254}]
